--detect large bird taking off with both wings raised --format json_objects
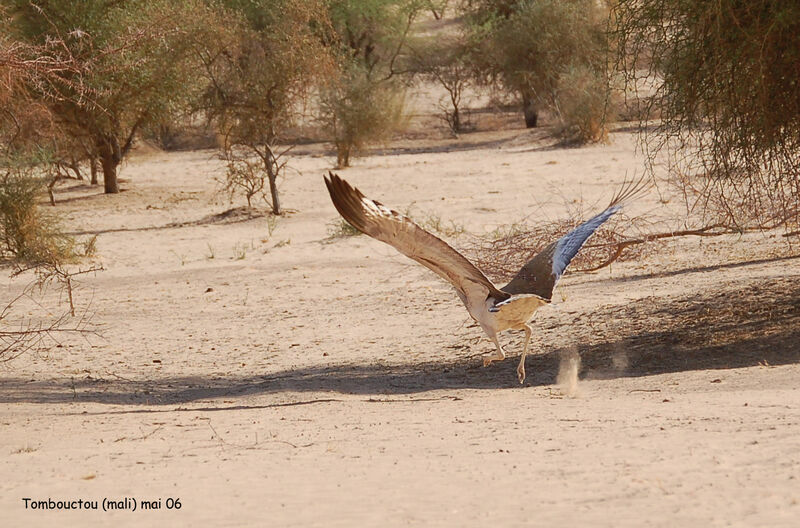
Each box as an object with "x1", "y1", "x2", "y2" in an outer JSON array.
[{"x1": 325, "y1": 172, "x2": 644, "y2": 383}]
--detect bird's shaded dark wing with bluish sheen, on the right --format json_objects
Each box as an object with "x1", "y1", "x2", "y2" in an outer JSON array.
[{"x1": 501, "y1": 178, "x2": 647, "y2": 301}]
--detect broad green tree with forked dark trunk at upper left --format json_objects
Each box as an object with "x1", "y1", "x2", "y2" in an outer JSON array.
[{"x1": 10, "y1": 0, "x2": 209, "y2": 193}]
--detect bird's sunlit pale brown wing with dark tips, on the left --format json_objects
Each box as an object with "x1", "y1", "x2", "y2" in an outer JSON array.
[{"x1": 325, "y1": 172, "x2": 510, "y2": 307}]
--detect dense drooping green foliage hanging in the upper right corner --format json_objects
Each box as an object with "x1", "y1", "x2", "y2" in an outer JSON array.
[{"x1": 612, "y1": 0, "x2": 800, "y2": 228}]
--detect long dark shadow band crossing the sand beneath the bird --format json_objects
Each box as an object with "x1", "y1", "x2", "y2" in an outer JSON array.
[{"x1": 0, "y1": 277, "x2": 800, "y2": 412}]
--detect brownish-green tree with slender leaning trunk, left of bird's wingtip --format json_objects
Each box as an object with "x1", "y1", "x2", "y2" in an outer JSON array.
[{"x1": 195, "y1": 0, "x2": 332, "y2": 214}]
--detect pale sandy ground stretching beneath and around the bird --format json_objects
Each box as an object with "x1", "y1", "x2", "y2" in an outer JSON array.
[{"x1": 0, "y1": 130, "x2": 800, "y2": 527}]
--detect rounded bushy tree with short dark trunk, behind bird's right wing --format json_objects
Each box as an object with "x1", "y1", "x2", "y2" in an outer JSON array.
[{"x1": 465, "y1": 0, "x2": 607, "y2": 133}]
